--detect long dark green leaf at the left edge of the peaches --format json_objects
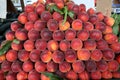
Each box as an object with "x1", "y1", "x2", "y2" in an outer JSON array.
[{"x1": 0, "y1": 41, "x2": 12, "y2": 55}]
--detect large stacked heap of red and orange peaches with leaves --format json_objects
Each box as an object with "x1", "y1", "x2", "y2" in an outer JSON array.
[{"x1": 0, "y1": 0, "x2": 120, "y2": 80}]
